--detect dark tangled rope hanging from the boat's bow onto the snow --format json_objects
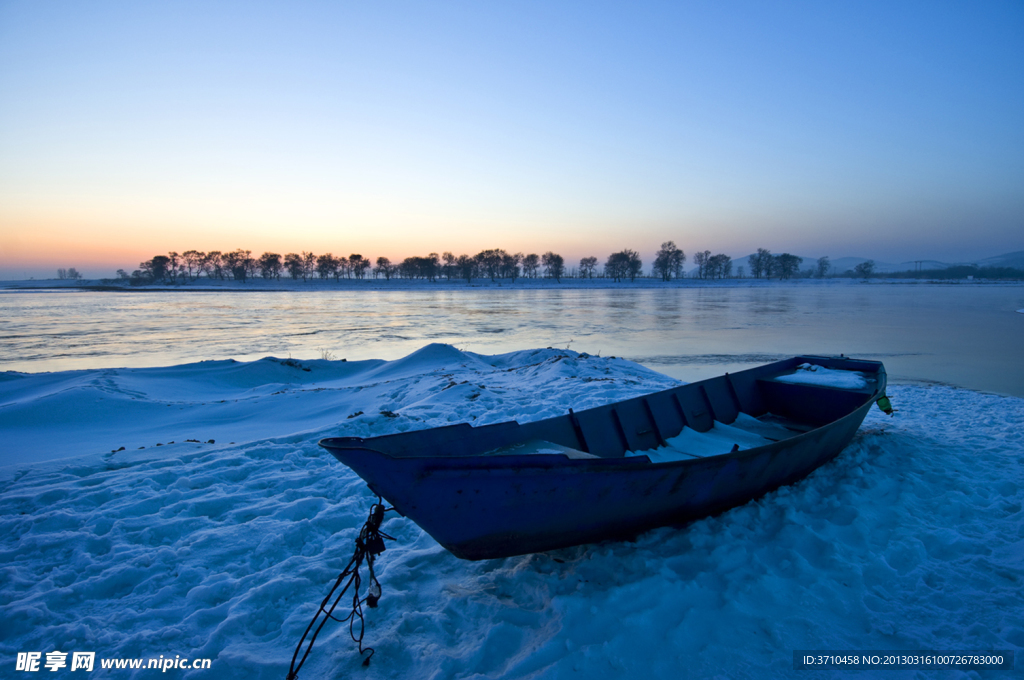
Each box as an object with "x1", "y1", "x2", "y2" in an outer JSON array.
[{"x1": 288, "y1": 496, "x2": 394, "y2": 680}]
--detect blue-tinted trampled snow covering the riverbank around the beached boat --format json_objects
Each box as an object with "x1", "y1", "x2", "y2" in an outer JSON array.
[{"x1": 0, "y1": 345, "x2": 1024, "y2": 680}]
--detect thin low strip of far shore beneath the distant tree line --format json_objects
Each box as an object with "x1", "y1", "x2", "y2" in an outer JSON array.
[{"x1": 0, "y1": 279, "x2": 1024, "y2": 293}]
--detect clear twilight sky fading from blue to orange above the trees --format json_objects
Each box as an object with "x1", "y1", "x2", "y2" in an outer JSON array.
[{"x1": 0, "y1": 1, "x2": 1024, "y2": 280}]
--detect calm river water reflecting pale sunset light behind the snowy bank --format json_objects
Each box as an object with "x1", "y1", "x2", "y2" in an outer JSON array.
[{"x1": 0, "y1": 284, "x2": 1024, "y2": 396}]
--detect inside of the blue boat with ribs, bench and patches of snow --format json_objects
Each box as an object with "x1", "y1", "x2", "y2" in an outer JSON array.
[{"x1": 323, "y1": 356, "x2": 885, "y2": 462}]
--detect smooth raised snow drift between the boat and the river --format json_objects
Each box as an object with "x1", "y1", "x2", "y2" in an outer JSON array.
[{"x1": 0, "y1": 344, "x2": 677, "y2": 466}]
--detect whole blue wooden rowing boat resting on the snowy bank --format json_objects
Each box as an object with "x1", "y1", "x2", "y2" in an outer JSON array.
[{"x1": 321, "y1": 356, "x2": 889, "y2": 559}]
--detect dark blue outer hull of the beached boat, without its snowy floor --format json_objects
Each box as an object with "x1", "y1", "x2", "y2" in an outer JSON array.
[{"x1": 322, "y1": 357, "x2": 885, "y2": 560}]
